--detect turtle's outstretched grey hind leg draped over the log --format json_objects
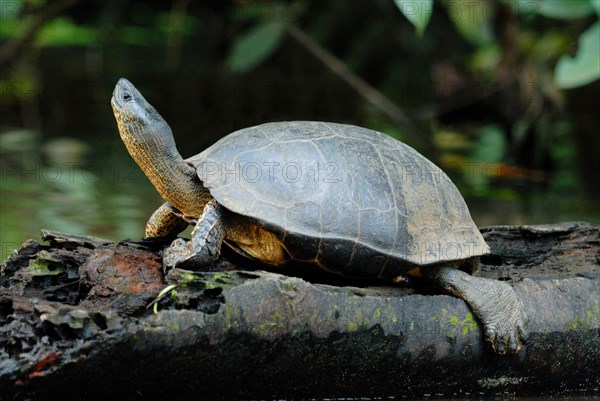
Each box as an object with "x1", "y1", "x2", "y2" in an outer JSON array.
[{"x1": 421, "y1": 267, "x2": 527, "y2": 354}]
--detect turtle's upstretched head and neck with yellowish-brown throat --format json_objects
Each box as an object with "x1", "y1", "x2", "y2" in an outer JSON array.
[{"x1": 110, "y1": 78, "x2": 210, "y2": 216}]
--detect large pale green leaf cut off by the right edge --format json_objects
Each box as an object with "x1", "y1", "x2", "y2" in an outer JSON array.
[{"x1": 554, "y1": 22, "x2": 600, "y2": 89}]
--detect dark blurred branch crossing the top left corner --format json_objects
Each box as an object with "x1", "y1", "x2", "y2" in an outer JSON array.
[{"x1": 0, "y1": 0, "x2": 79, "y2": 68}]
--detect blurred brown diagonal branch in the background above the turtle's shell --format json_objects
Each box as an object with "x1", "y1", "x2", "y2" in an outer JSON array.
[{"x1": 287, "y1": 25, "x2": 435, "y2": 154}]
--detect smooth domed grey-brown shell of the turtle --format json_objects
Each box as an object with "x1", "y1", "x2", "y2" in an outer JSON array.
[{"x1": 187, "y1": 121, "x2": 489, "y2": 277}]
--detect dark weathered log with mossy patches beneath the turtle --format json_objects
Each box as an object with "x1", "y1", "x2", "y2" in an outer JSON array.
[{"x1": 0, "y1": 223, "x2": 600, "y2": 400}]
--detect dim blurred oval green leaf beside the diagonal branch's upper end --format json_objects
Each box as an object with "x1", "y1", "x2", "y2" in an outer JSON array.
[{"x1": 227, "y1": 22, "x2": 285, "y2": 73}]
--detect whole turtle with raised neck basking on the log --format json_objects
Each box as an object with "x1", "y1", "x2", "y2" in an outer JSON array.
[{"x1": 111, "y1": 78, "x2": 527, "y2": 354}]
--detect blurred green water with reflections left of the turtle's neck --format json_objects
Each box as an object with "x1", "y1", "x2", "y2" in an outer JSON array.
[{"x1": 0, "y1": 131, "x2": 161, "y2": 259}]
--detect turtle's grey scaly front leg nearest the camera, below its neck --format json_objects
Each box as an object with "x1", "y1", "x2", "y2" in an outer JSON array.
[{"x1": 163, "y1": 199, "x2": 225, "y2": 272}]
